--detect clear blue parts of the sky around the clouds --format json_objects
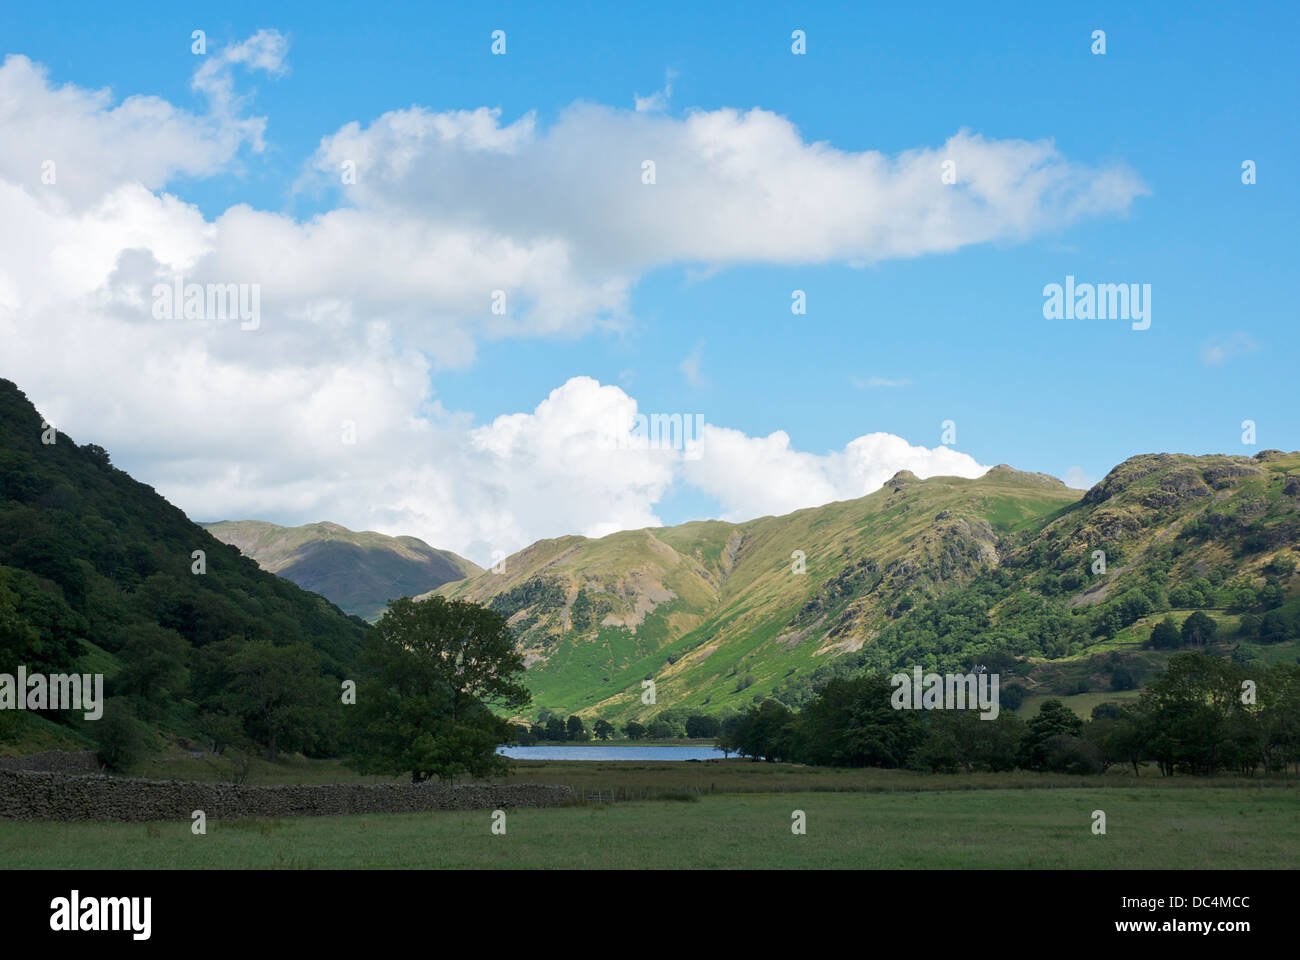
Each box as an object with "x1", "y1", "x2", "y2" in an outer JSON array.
[{"x1": 0, "y1": 3, "x2": 1300, "y2": 554}]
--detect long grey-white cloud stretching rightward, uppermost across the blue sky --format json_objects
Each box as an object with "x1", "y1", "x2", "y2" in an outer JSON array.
[{"x1": 313, "y1": 103, "x2": 1145, "y2": 274}]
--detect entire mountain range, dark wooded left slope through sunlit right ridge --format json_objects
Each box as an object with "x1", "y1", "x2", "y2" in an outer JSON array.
[{"x1": 0, "y1": 369, "x2": 1300, "y2": 749}]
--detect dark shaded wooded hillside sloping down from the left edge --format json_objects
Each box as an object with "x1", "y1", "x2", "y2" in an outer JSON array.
[{"x1": 0, "y1": 380, "x2": 368, "y2": 749}]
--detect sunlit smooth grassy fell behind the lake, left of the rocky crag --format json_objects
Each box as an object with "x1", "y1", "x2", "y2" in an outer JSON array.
[{"x1": 438, "y1": 467, "x2": 1080, "y2": 715}]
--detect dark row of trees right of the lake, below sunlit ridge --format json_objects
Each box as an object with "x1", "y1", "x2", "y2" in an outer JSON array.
[{"x1": 716, "y1": 652, "x2": 1300, "y2": 777}]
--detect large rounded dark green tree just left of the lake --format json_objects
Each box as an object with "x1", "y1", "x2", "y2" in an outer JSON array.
[{"x1": 352, "y1": 597, "x2": 530, "y2": 783}]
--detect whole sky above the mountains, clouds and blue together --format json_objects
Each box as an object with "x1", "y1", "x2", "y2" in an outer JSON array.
[{"x1": 0, "y1": 3, "x2": 1300, "y2": 563}]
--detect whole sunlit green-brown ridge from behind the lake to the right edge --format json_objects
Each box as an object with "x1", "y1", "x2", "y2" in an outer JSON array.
[{"x1": 437, "y1": 450, "x2": 1300, "y2": 718}]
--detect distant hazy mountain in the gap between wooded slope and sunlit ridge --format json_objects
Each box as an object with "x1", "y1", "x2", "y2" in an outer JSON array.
[{"x1": 204, "y1": 520, "x2": 482, "y2": 622}]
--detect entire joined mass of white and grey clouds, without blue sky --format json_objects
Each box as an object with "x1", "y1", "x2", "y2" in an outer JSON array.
[{"x1": 0, "y1": 39, "x2": 1143, "y2": 562}]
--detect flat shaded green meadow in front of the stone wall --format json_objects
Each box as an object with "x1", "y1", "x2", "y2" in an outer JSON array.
[{"x1": 0, "y1": 787, "x2": 1300, "y2": 870}]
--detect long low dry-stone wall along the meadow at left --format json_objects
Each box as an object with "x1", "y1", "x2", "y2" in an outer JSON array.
[{"x1": 0, "y1": 770, "x2": 575, "y2": 822}]
